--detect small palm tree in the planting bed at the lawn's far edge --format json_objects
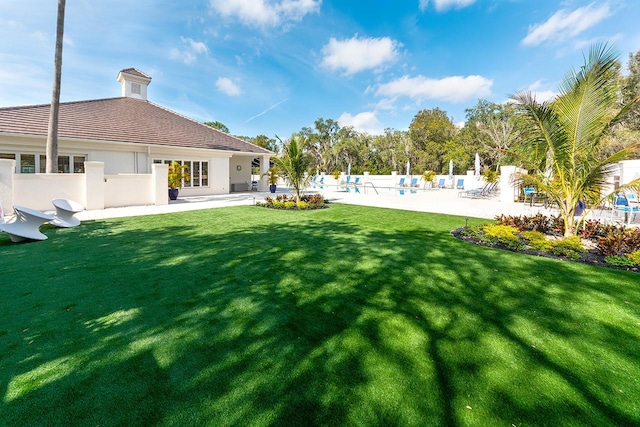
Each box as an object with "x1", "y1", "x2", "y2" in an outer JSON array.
[{"x1": 273, "y1": 135, "x2": 312, "y2": 204}]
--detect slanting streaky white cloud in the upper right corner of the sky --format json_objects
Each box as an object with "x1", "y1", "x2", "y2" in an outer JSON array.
[{"x1": 522, "y1": 3, "x2": 611, "y2": 46}]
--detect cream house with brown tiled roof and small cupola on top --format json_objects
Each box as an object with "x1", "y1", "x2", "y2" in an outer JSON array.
[{"x1": 0, "y1": 68, "x2": 274, "y2": 196}]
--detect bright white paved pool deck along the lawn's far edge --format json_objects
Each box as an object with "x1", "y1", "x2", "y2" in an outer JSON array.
[{"x1": 71, "y1": 187, "x2": 555, "y2": 221}]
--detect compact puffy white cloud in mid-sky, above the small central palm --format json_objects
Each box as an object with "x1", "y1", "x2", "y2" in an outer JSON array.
[{"x1": 322, "y1": 35, "x2": 401, "y2": 75}]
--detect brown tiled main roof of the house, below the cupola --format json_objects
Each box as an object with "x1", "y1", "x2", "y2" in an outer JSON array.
[{"x1": 0, "y1": 97, "x2": 273, "y2": 154}]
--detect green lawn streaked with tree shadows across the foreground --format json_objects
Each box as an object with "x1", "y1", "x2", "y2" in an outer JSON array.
[{"x1": 0, "y1": 205, "x2": 640, "y2": 426}]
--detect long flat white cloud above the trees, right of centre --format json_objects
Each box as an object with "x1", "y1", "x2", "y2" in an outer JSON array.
[{"x1": 376, "y1": 76, "x2": 493, "y2": 103}]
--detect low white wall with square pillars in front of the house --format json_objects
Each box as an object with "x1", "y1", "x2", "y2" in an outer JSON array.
[{"x1": 0, "y1": 159, "x2": 169, "y2": 214}]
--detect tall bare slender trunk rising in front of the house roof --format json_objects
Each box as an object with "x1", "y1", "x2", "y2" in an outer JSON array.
[{"x1": 45, "y1": 0, "x2": 65, "y2": 173}]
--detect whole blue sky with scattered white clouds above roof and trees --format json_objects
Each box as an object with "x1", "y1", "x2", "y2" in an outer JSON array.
[{"x1": 0, "y1": 0, "x2": 640, "y2": 138}]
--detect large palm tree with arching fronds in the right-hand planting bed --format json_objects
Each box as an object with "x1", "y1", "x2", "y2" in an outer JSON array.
[{"x1": 511, "y1": 44, "x2": 640, "y2": 237}]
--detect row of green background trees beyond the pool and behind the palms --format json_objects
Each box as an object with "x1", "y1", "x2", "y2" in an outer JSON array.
[{"x1": 207, "y1": 50, "x2": 640, "y2": 178}]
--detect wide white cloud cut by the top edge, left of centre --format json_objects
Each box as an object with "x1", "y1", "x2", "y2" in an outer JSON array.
[{"x1": 209, "y1": 0, "x2": 322, "y2": 28}]
